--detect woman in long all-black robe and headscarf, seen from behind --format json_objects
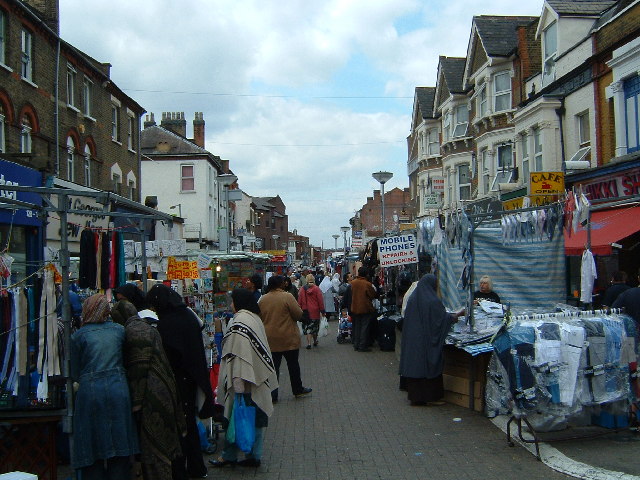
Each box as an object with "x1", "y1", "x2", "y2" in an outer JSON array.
[{"x1": 147, "y1": 283, "x2": 214, "y2": 478}]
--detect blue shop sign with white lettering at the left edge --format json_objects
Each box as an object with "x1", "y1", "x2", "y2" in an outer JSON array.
[{"x1": 0, "y1": 160, "x2": 42, "y2": 226}]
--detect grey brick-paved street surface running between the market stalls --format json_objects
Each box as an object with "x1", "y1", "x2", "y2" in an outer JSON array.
[{"x1": 59, "y1": 322, "x2": 640, "y2": 480}]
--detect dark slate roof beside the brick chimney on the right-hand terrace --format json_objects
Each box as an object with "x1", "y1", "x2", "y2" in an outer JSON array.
[{"x1": 473, "y1": 15, "x2": 538, "y2": 57}]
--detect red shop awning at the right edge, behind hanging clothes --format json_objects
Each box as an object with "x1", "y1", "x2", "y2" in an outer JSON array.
[{"x1": 564, "y1": 205, "x2": 640, "y2": 255}]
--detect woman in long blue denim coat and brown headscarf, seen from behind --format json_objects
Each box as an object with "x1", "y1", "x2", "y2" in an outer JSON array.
[{"x1": 71, "y1": 295, "x2": 139, "y2": 480}]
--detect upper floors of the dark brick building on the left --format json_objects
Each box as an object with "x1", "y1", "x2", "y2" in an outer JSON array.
[{"x1": 0, "y1": 0, "x2": 144, "y2": 197}]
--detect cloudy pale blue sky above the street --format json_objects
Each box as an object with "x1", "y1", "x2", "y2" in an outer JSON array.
[{"x1": 60, "y1": 0, "x2": 542, "y2": 248}]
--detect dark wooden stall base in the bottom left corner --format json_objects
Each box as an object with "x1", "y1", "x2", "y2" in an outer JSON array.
[{"x1": 0, "y1": 410, "x2": 65, "y2": 480}]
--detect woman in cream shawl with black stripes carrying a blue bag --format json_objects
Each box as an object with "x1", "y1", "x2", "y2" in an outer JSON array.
[{"x1": 209, "y1": 288, "x2": 278, "y2": 467}]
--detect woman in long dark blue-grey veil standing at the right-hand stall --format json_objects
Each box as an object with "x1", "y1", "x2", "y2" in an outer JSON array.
[{"x1": 400, "y1": 274, "x2": 464, "y2": 405}]
